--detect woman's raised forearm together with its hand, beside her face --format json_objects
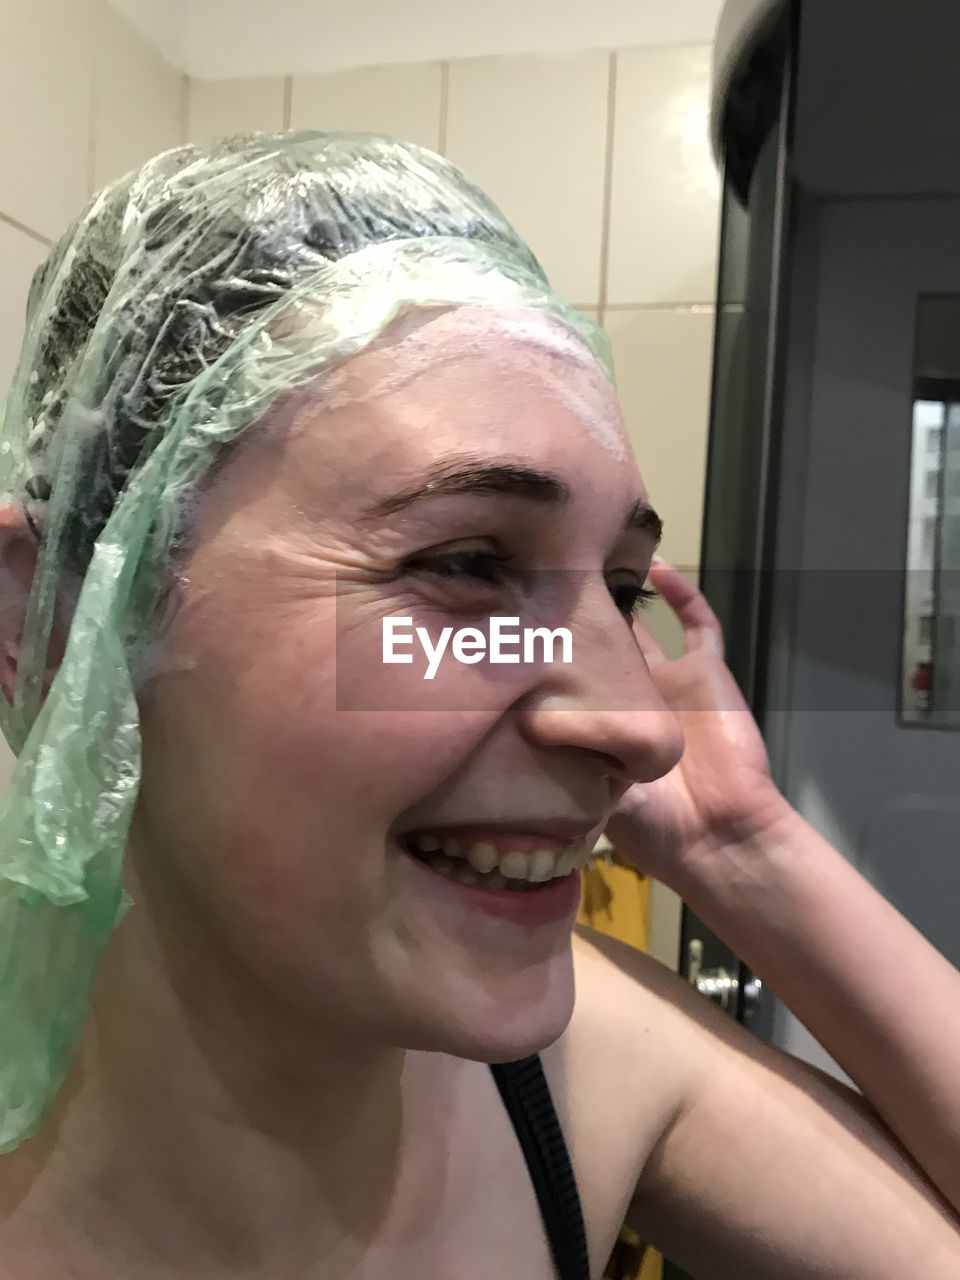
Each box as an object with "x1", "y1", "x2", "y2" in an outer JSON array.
[{"x1": 608, "y1": 564, "x2": 960, "y2": 1218}]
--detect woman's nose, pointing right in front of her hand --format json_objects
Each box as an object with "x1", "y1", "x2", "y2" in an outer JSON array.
[{"x1": 524, "y1": 598, "x2": 684, "y2": 783}]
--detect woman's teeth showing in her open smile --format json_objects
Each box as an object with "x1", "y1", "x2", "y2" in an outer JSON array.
[{"x1": 408, "y1": 835, "x2": 593, "y2": 890}]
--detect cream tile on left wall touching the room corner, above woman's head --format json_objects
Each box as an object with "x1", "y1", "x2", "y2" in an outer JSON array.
[{"x1": 93, "y1": 4, "x2": 187, "y2": 191}]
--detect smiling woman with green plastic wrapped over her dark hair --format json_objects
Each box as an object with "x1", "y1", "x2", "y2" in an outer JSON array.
[{"x1": 0, "y1": 134, "x2": 960, "y2": 1280}]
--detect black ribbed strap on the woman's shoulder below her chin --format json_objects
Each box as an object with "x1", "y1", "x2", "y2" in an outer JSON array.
[{"x1": 490, "y1": 1055, "x2": 590, "y2": 1280}]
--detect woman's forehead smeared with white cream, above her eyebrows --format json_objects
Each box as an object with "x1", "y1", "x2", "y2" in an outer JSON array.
[{"x1": 193, "y1": 327, "x2": 646, "y2": 552}]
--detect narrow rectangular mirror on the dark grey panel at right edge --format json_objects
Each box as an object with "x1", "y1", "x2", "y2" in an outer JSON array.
[{"x1": 900, "y1": 294, "x2": 960, "y2": 728}]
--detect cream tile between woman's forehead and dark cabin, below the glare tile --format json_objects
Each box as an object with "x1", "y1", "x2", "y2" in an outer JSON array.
[{"x1": 605, "y1": 307, "x2": 714, "y2": 566}]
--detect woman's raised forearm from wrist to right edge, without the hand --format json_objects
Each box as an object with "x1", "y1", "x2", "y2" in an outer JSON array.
[{"x1": 684, "y1": 803, "x2": 960, "y2": 1212}]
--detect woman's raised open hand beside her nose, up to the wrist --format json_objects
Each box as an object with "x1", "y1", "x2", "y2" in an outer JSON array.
[{"x1": 607, "y1": 561, "x2": 791, "y2": 890}]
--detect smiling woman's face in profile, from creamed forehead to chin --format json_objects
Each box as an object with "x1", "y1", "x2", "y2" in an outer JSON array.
[{"x1": 134, "y1": 311, "x2": 682, "y2": 1061}]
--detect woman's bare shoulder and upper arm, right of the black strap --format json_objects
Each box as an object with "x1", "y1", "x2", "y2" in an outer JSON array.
[{"x1": 563, "y1": 929, "x2": 960, "y2": 1280}]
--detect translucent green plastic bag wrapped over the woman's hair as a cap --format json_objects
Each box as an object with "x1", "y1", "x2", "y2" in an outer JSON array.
[{"x1": 0, "y1": 132, "x2": 612, "y2": 1152}]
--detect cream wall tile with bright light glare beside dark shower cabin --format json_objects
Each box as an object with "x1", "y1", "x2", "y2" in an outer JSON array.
[{"x1": 607, "y1": 45, "x2": 719, "y2": 303}]
